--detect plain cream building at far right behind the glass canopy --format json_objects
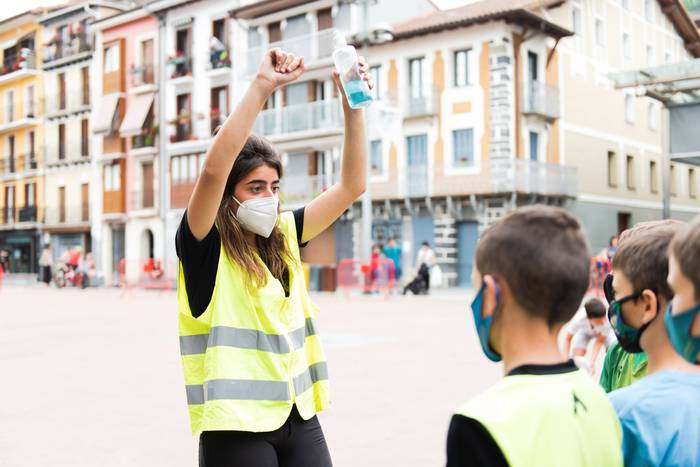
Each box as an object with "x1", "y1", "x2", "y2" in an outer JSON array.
[{"x1": 549, "y1": 0, "x2": 700, "y2": 250}]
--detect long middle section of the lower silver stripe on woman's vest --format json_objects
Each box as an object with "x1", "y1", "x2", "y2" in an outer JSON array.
[{"x1": 204, "y1": 379, "x2": 289, "y2": 401}]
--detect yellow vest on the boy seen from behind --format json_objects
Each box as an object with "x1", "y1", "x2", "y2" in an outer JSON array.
[{"x1": 457, "y1": 370, "x2": 622, "y2": 467}]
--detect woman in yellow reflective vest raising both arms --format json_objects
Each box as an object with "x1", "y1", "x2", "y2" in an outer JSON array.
[{"x1": 176, "y1": 49, "x2": 372, "y2": 467}]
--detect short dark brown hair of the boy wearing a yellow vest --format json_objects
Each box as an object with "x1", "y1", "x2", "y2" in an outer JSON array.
[{"x1": 476, "y1": 205, "x2": 590, "y2": 327}]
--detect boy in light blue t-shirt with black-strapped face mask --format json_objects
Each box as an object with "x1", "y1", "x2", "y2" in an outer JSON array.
[{"x1": 607, "y1": 221, "x2": 700, "y2": 466}]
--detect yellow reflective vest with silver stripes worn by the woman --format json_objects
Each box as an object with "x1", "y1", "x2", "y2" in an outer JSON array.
[{"x1": 178, "y1": 212, "x2": 329, "y2": 435}]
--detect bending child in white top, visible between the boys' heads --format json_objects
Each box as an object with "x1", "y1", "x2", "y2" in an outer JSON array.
[{"x1": 564, "y1": 298, "x2": 615, "y2": 373}]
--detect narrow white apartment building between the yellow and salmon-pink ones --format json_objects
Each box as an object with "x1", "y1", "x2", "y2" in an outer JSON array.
[{"x1": 41, "y1": 1, "x2": 126, "y2": 268}]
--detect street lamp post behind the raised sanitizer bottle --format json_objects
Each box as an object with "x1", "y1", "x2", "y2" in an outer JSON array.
[{"x1": 349, "y1": 0, "x2": 394, "y2": 261}]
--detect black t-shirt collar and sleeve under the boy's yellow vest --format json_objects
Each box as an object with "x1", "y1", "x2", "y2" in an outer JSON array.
[{"x1": 447, "y1": 360, "x2": 578, "y2": 467}]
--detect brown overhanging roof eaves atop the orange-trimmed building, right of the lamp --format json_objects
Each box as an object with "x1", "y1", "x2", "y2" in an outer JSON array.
[{"x1": 394, "y1": 0, "x2": 572, "y2": 39}]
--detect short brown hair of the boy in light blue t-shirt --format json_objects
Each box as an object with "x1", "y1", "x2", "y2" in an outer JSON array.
[{"x1": 613, "y1": 219, "x2": 683, "y2": 300}]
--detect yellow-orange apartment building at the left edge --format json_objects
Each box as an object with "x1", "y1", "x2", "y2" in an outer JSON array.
[{"x1": 0, "y1": 10, "x2": 44, "y2": 273}]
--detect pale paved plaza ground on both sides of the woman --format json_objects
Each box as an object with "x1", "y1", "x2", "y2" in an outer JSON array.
[{"x1": 0, "y1": 285, "x2": 501, "y2": 467}]
